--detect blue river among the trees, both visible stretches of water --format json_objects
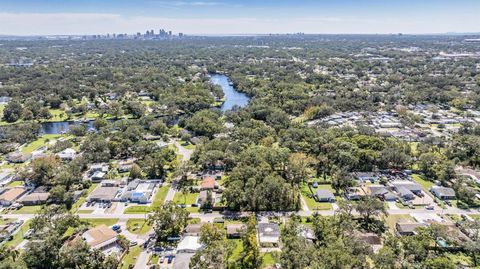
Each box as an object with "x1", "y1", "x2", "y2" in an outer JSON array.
[{"x1": 40, "y1": 74, "x2": 250, "y2": 134}]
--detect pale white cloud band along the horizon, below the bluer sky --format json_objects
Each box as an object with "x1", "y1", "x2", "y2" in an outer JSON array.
[{"x1": 0, "y1": 12, "x2": 480, "y2": 35}]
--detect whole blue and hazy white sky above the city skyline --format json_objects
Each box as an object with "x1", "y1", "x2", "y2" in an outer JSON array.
[{"x1": 0, "y1": 0, "x2": 480, "y2": 35}]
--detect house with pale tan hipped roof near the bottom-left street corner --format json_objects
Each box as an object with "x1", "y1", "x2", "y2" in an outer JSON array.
[{"x1": 82, "y1": 225, "x2": 121, "y2": 253}]
